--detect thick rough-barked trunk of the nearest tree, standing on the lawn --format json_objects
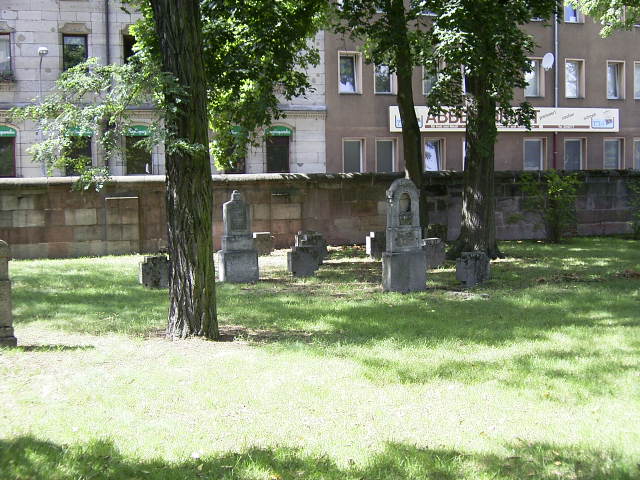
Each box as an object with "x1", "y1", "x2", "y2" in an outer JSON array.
[{"x1": 151, "y1": 0, "x2": 219, "y2": 339}]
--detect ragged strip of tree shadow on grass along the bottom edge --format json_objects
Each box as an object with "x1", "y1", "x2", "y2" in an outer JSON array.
[{"x1": 0, "y1": 436, "x2": 639, "y2": 480}]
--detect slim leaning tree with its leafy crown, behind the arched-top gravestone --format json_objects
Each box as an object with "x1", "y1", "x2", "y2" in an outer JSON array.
[{"x1": 333, "y1": 0, "x2": 431, "y2": 229}]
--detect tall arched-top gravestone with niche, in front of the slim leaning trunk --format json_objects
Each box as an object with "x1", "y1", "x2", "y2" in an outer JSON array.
[{"x1": 382, "y1": 178, "x2": 427, "y2": 293}]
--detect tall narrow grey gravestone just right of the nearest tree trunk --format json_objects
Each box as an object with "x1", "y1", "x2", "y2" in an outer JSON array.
[{"x1": 218, "y1": 190, "x2": 259, "y2": 283}]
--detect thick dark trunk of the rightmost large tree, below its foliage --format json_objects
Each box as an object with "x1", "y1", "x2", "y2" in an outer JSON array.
[{"x1": 448, "y1": 77, "x2": 502, "y2": 259}]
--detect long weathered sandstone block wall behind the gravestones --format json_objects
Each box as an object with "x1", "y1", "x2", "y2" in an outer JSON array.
[{"x1": 0, "y1": 171, "x2": 640, "y2": 258}]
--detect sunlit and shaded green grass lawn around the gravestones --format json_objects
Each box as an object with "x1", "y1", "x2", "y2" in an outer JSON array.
[{"x1": 0, "y1": 238, "x2": 640, "y2": 480}]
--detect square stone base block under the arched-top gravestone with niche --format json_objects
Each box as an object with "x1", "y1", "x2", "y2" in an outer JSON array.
[{"x1": 382, "y1": 250, "x2": 427, "y2": 293}]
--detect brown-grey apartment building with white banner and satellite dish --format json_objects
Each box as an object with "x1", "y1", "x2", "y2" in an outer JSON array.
[{"x1": 325, "y1": 7, "x2": 640, "y2": 172}]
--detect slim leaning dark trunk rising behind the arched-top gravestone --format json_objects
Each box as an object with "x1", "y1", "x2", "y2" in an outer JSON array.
[{"x1": 389, "y1": 0, "x2": 429, "y2": 232}]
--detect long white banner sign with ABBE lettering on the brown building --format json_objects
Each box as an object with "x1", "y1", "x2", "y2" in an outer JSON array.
[{"x1": 389, "y1": 105, "x2": 620, "y2": 132}]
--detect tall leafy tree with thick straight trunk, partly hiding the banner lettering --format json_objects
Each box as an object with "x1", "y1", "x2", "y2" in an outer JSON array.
[{"x1": 430, "y1": 0, "x2": 557, "y2": 258}]
